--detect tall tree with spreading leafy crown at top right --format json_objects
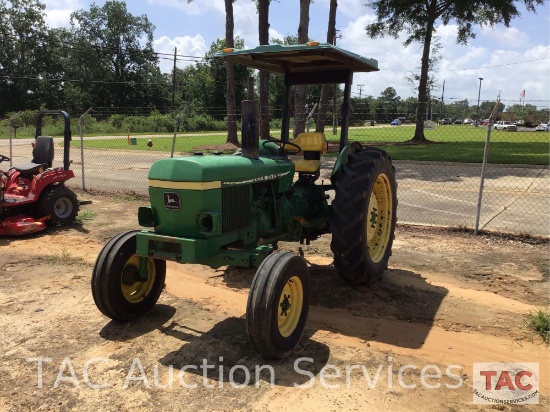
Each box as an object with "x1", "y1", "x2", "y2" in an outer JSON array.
[{"x1": 366, "y1": 0, "x2": 545, "y2": 142}]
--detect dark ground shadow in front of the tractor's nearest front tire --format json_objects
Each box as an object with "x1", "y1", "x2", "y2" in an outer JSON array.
[{"x1": 159, "y1": 317, "x2": 330, "y2": 387}]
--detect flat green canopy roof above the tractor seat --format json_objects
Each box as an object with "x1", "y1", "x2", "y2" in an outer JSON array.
[{"x1": 214, "y1": 42, "x2": 379, "y2": 74}]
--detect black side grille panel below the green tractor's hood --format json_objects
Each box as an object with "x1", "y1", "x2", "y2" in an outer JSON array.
[{"x1": 222, "y1": 185, "x2": 251, "y2": 233}]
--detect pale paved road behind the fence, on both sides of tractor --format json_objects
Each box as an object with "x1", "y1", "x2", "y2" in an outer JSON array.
[{"x1": 0, "y1": 140, "x2": 550, "y2": 237}]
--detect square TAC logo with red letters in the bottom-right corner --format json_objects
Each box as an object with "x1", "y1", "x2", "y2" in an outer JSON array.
[{"x1": 473, "y1": 363, "x2": 539, "y2": 405}]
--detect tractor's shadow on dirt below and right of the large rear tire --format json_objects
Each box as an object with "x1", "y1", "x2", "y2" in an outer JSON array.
[{"x1": 223, "y1": 255, "x2": 448, "y2": 349}]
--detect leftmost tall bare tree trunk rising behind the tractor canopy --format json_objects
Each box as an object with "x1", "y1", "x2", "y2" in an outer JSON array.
[{"x1": 225, "y1": 0, "x2": 239, "y2": 146}]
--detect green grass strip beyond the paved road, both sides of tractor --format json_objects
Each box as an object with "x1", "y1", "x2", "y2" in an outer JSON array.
[{"x1": 35, "y1": 125, "x2": 550, "y2": 165}]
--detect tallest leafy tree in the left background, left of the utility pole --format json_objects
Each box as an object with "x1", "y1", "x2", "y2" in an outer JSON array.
[{"x1": 70, "y1": 1, "x2": 160, "y2": 107}]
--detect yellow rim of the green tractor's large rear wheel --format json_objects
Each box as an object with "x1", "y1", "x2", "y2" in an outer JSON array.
[{"x1": 366, "y1": 173, "x2": 393, "y2": 263}]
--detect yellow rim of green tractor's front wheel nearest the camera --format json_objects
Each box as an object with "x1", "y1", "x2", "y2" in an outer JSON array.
[{"x1": 277, "y1": 276, "x2": 304, "y2": 338}]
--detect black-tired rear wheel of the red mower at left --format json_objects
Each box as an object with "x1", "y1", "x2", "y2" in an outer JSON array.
[{"x1": 36, "y1": 185, "x2": 79, "y2": 226}]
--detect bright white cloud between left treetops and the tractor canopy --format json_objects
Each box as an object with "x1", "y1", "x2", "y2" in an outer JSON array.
[{"x1": 153, "y1": 34, "x2": 209, "y2": 73}]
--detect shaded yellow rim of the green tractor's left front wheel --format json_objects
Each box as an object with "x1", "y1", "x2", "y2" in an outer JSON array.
[{"x1": 120, "y1": 255, "x2": 156, "y2": 303}]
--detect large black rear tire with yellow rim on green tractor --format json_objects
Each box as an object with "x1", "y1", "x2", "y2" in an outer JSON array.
[{"x1": 330, "y1": 148, "x2": 397, "y2": 285}]
